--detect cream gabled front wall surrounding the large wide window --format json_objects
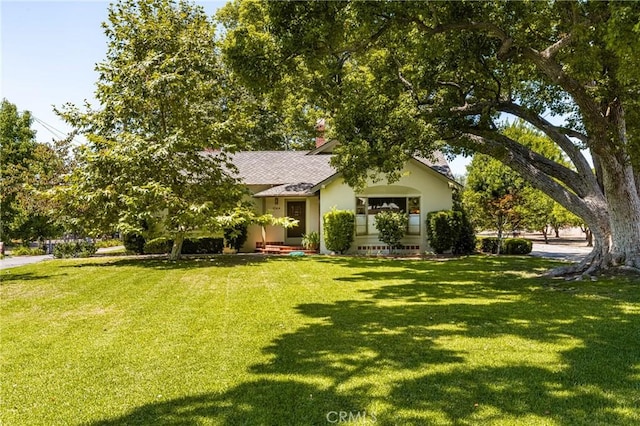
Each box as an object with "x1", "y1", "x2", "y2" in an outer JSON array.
[{"x1": 320, "y1": 160, "x2": 453, "y2": 253}]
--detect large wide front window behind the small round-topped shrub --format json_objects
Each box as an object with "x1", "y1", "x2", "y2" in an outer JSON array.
[{"x1": 356, "y1": 197, "x2": 420, "y2": 235}]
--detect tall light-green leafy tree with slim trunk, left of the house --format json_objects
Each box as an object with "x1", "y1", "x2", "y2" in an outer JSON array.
[{"x1": 59, "y1": 0, "x2": 242, "y2": 259}]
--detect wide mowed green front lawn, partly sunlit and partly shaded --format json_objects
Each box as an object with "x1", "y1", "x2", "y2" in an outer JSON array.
[{"x1": 0, "y1": 256, "x2": 640, "y2": 426}]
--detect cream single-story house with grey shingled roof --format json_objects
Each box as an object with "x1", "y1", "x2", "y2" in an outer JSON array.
[{"x1": 232, "y1": 138, "x2": 457, "y2": 253}]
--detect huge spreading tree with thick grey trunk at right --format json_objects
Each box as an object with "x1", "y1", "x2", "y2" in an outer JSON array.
[{"x1": 224, "y1": 1, "x2": 640, "y2": 273}]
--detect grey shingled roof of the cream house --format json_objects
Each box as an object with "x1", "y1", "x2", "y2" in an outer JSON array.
[{"x1": 225, "y1": 151, "x2": 453, "y2": 197}]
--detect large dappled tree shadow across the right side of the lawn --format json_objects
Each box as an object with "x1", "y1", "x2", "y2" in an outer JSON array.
[{"x1": 87, "y1": 259, "x2": 640, "y2": 426}]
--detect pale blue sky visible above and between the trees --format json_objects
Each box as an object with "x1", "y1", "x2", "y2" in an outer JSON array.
[{"x1": 0, "y1": 0, "x2": 469, "y2": 175}]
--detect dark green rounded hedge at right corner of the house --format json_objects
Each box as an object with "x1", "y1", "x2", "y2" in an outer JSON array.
[{"x1": 427, "y1": 210, "x2": 476, "y2": 254}]
